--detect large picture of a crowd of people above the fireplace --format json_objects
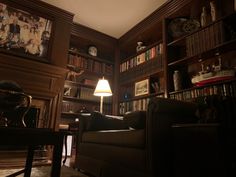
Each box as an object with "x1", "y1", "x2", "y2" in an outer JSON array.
[{"x1": 0, "y1": 3, "x2": 52, "y2": 60}]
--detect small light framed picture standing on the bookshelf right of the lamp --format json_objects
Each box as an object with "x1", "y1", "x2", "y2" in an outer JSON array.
[{"x1": 134, "y1": 79, "x2": 149, "y2": 96}]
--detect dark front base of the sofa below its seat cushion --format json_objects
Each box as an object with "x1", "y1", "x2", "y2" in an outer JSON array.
[{"x1": 78, "y1": 143, "x2": 147, "y2": 173}]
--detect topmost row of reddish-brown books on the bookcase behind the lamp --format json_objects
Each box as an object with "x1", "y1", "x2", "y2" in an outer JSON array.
[{"x1": 68, "y1": 54, "x2": 113, "y2": 75}]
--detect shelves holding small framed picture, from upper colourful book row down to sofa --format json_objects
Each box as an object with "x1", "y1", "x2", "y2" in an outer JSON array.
[{"x1": 119, "y1": 41, "x2": 164, "y2": 115}]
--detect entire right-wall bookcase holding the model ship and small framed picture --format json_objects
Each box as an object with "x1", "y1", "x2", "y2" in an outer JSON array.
[{"x1": 116, "y1": 0, "x2": 236, "y2": 114}]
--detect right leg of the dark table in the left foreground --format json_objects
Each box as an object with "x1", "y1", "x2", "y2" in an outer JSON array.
[{"x1": 51, "y1": 138, "x2": 63, "y2": 177}]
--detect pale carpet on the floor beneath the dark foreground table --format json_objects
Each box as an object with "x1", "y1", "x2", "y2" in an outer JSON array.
[{"x1": 0, "y1": 166, "x2": 89, "y2": 177}]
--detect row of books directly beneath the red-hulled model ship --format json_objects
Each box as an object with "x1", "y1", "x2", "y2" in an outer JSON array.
[{"x1": 170, "y1": 82, "x2": 236, "y2": 101}]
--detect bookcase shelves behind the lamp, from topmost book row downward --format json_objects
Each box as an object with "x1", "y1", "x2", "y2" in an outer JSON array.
[{"x1": 61, "y1": 50, "x2": 113, "y2": 122}]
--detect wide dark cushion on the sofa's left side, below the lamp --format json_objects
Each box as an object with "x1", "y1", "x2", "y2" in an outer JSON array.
[{"x1": 86, "y1": 111, "x2": 128, "y2": 131}]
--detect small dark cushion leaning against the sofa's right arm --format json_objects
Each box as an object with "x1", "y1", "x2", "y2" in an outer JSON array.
[{"x1": 124, "y1": 111, "x2": 146, "y2": 129}]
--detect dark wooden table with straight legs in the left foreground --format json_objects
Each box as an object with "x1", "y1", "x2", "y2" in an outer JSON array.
[{"x1": 0, "y1": 127, "x2": 65, "y2": 177}]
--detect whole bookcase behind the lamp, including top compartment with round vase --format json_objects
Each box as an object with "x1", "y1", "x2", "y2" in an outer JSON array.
[{"x1": 60, "y1": 24, "x2": 114, "y2": 125}]
